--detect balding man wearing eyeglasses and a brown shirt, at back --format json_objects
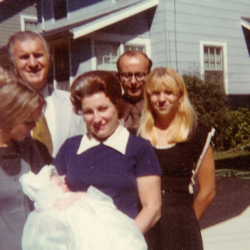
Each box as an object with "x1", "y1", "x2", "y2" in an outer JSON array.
[{"x1": 116, "y1": 50, "x2": 152, "y2": 128}]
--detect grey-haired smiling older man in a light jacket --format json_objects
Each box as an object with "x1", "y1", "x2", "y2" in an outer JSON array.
[{"x1": 8, "y1": 31, "x2": 85, "y2": 163}]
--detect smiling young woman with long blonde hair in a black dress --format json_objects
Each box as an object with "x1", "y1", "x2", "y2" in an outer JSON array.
[{"x1": 138, "y1": 68, "x2": 215, "y2": 250}]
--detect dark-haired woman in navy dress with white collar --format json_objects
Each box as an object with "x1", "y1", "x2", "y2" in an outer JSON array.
[{"x1": 53, "y1": 71, "x2": 161, "y2": 233}]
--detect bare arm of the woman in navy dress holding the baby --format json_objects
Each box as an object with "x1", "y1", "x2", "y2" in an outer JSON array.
[{"x1": 135, "y1": 175, "x2": 161, "y2": 234}]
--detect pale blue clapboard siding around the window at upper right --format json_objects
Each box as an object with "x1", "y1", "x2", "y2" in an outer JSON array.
[{"x1": 150, "y1": 0, "x2": 250, "y2": 94}]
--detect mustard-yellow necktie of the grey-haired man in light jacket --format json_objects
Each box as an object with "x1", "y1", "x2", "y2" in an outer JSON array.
[{"x1": 32, "y1": 115, "x2": 53, "y2": 155}]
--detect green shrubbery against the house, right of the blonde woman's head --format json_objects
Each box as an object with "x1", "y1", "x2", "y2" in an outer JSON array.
[{"x1": 183, "y1": 75, "x2": 250, "y2": 151}]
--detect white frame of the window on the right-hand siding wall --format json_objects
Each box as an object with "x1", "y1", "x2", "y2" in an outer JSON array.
[{"x1": 200, "y1": 41, "x2": 228, "y2": 94}]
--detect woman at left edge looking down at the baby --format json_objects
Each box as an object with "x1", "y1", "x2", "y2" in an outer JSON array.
[{"x1": 0, "y1": 67, "x2": 45, "y2": 250}]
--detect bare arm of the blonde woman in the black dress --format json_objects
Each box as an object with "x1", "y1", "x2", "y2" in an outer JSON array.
[{"x1": 194, "y1": 146, "x2": 215, "y2": 221}]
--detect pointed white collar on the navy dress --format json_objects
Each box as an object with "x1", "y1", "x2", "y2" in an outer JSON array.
[{"x1": 77, "y1": 125, "x2": 129, "y2": 155}]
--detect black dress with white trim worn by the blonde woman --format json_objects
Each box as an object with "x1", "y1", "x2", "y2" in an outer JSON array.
[{"x1": 146, "y1": 127, "x2": 214, "y2": 250}]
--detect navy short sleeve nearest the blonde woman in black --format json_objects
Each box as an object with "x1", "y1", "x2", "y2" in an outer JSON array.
[{"x1": 133, "y1": 137, "x2": 162, "y2": 177}]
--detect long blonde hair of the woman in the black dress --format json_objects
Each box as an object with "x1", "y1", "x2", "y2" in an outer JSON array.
[{"x1": 138, "y1": 68, "x2": 197, "y2": 146}]
